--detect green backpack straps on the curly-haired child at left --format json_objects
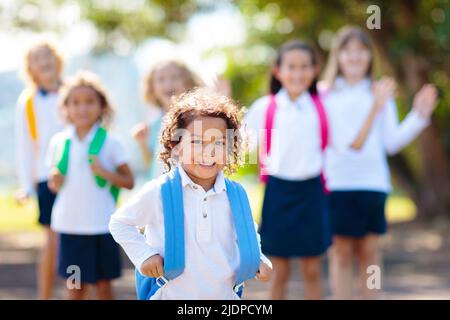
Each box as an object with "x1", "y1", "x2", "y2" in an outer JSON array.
[{"x1": 56, "y1": 127, "x2": 120, "y2": 203}]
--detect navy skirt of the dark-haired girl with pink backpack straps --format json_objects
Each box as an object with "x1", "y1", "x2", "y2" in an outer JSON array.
[{"x1": 260, "y1": 176, "x2": 331, "y2": 258}]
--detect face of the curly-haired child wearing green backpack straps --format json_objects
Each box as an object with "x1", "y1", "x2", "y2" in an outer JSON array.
[{"x1": 66, "y1": 86, "x2": 103, "y2": 129}]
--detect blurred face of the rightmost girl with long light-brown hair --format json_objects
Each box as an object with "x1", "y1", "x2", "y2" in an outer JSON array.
[{"x1": 338, "y1": 39, "x2": 372, "y2": 79}]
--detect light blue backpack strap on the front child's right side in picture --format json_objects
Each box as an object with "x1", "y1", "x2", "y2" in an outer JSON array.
[{"x1": 225, "y1": 179, "x2": 261, "y2": 291}]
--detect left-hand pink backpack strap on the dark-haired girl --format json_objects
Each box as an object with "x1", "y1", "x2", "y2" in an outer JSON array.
[{"x1": 259, "y1": 94, "x2": 277, "y2": 183}]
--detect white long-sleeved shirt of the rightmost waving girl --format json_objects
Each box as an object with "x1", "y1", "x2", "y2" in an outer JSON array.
[{"x1": 325, "y1": 77, "x2": 430, "y2": 192}]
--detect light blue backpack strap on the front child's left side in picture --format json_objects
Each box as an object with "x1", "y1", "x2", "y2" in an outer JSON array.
[{"x1": 161, "y1": 168, "x2": 185, "y2": 280}]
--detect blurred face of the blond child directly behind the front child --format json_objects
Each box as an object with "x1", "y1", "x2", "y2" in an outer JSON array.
[{"x1": 152, "y1": 64, "x2": 185, "y2": 109}]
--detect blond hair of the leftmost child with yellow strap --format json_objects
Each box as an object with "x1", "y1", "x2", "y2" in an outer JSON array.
[{"x1": 21, "y1": 40, "x2": 64, "y2": 89}]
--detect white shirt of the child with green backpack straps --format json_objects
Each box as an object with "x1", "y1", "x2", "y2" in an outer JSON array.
[{"x1": 47, "y1": 125, "x2": 127, "y2": 235}]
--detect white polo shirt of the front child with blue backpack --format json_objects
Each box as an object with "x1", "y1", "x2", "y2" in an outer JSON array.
[{"x1": 110, "y1": 166, "x2": 271, "y2": 300}]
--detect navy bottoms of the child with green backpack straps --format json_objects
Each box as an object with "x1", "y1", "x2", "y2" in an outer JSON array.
[{"x1": 58, "y1": 234, "x2": 121, "y2": 284}]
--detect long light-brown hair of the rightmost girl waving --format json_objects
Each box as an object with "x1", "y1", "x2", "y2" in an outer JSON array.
[{"x1": 323, "y1": 26, "x2": 378, "y2": 86}]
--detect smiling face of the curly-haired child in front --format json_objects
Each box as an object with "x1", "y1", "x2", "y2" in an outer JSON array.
[{"x1": 179, "y1": 117, "x2": 227, "y2": 184}]
